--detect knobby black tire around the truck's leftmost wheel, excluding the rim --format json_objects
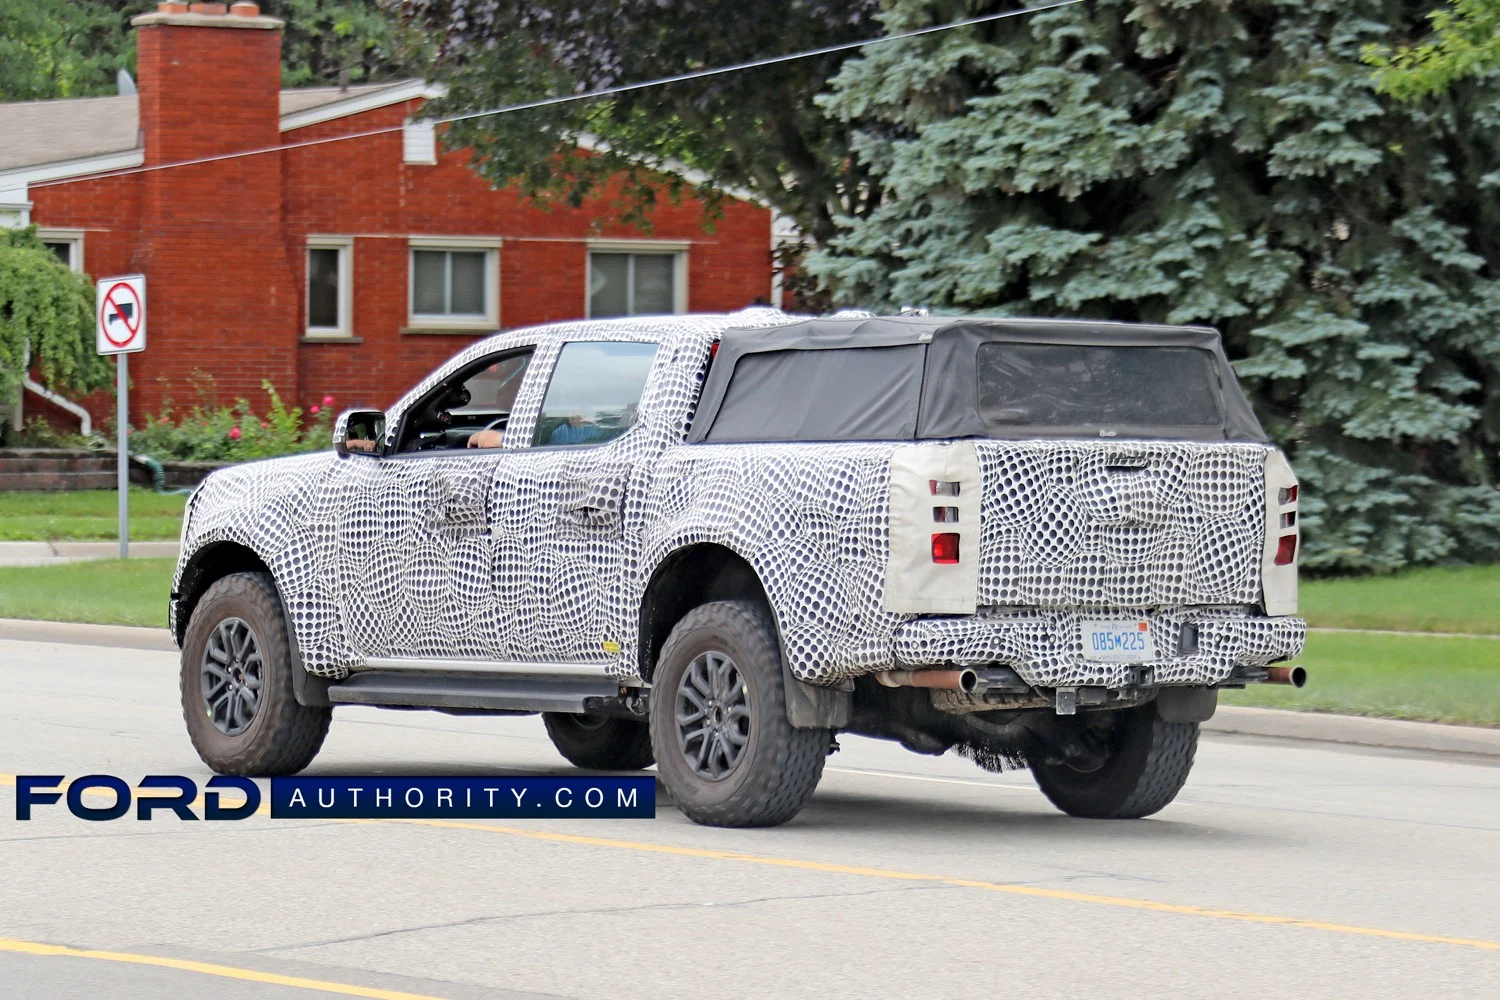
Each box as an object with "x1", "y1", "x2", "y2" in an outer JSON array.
[{"x1": 180, "y1": 573, "x2": 333, "y2": 775}]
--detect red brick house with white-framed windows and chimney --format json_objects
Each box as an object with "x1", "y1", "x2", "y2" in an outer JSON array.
[{"x1": 0, "y1": 3, "x2": 776, "y2": 426}]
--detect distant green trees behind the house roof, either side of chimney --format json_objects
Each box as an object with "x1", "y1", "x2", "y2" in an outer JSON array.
[{"x1": 0, "y1": 0, "x2": 432, "y2": 100}]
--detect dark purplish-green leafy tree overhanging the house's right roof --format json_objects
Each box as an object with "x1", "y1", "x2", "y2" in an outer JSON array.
[{"x1": 405, "y1": 0, "x2": 881, "y2": 238}]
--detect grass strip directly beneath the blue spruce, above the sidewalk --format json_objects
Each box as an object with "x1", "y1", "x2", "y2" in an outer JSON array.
[{"x1": 1301, "y1": 565, "x2": 1500, "y2": 636}]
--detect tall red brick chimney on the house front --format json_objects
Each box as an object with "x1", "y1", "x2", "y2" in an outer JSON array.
[{"x1": 131, "y1": 1, "x2": 300, "y2": 411}]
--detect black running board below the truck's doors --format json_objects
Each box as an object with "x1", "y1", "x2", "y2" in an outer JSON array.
[{"x1": 329, "y1": 669, "x2": 620, "y2": 712}]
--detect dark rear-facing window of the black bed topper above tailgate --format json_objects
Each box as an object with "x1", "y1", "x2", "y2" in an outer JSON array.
[{"x1": 975, "y1": 343, "x2": 1224, "y2": 429}]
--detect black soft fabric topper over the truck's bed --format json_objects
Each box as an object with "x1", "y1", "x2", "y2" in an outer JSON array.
[{"x1": 689, "y1": 316, "x2": 1266, "y2": 442}]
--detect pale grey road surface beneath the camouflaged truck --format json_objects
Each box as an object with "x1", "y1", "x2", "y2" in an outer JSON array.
[{"x1": 0, "y1": 640, "x2": 1500, "y2": 1000}]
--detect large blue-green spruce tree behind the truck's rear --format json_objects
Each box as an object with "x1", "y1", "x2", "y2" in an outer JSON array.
[{"x1": 810, "y1": 0, "x2": 1500, "y2": 570}]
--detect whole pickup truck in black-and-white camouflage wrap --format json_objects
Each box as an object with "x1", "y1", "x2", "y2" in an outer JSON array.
[{"x1": 171, "y1": 309, "x2": 1307, "y2": 826}]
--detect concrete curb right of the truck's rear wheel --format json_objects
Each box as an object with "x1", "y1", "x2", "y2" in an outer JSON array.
[{"x1": 1203, "y1": 705, "x2": 1500, "y2": 757}]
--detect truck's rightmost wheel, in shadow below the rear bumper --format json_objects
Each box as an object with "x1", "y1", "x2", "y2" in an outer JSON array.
[{"x1": 1031, "y1": 705, "x2": 1199, "y2": 820}]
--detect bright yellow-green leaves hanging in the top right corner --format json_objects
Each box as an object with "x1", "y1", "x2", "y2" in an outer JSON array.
[{"x1": 1365, "y1": 0, "x2": 1500, "y2": 100}]
